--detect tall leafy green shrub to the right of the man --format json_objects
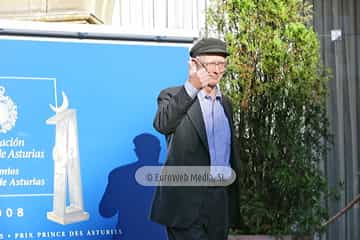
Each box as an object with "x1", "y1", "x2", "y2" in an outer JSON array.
[{"x1": 207, "y1": 0, "x2": 330, "y2": 235}]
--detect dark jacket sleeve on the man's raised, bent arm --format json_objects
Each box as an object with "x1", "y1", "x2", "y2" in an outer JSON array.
[{"x1": 153, "y1": 87, "x2": 196, "y2": 134}]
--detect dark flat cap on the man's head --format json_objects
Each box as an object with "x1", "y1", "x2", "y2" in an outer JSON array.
[{"x1": 190, "y1": 38, "x2": 229, "y2": 57}]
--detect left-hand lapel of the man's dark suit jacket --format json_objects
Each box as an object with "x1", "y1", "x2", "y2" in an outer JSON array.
[{"x1": 187, "y1": 99, "x2": 209, "y2": 151}]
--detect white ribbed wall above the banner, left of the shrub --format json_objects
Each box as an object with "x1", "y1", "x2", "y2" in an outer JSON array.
[{"x1": 112, "y1": 0, "x2": 209, "y2": 34}]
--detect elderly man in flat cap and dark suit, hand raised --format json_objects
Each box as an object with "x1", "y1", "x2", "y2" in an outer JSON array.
[{"x1": 151, "y1": 38, "x2": 239, "y2": 240}]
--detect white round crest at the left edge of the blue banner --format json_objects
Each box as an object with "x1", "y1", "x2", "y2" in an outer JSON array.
[{"x1": 0, "y1": 86, "x2": 17, "y2": 133}]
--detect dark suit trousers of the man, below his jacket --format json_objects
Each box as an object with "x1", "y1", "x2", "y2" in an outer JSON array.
[{"x1": 166, "y1": 187, "x2": 229, "y2": 240}]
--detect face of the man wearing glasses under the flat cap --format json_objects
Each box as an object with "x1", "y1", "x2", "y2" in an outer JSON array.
[{"x1": 197, "y1": 54, "x2": 226, "y2": 87}]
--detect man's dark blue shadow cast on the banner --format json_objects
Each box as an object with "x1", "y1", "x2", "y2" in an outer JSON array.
[{"x1": 99, "y1": 133, "x2": 166, "y2": 240}]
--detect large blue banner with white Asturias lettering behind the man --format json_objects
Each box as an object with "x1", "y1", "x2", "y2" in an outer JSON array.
[{"x1": 0, "y1": 36, "x2": 188, "y2": 240}]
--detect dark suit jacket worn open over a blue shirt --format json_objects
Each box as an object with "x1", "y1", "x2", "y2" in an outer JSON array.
[{"x1": 150, "y1": 86, "x2": 239, "y2": 228}]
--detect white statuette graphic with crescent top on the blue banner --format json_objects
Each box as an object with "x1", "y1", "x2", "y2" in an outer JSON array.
[{"x1": 46, "y1": 92, "x2": 89, "y2": 225}]
